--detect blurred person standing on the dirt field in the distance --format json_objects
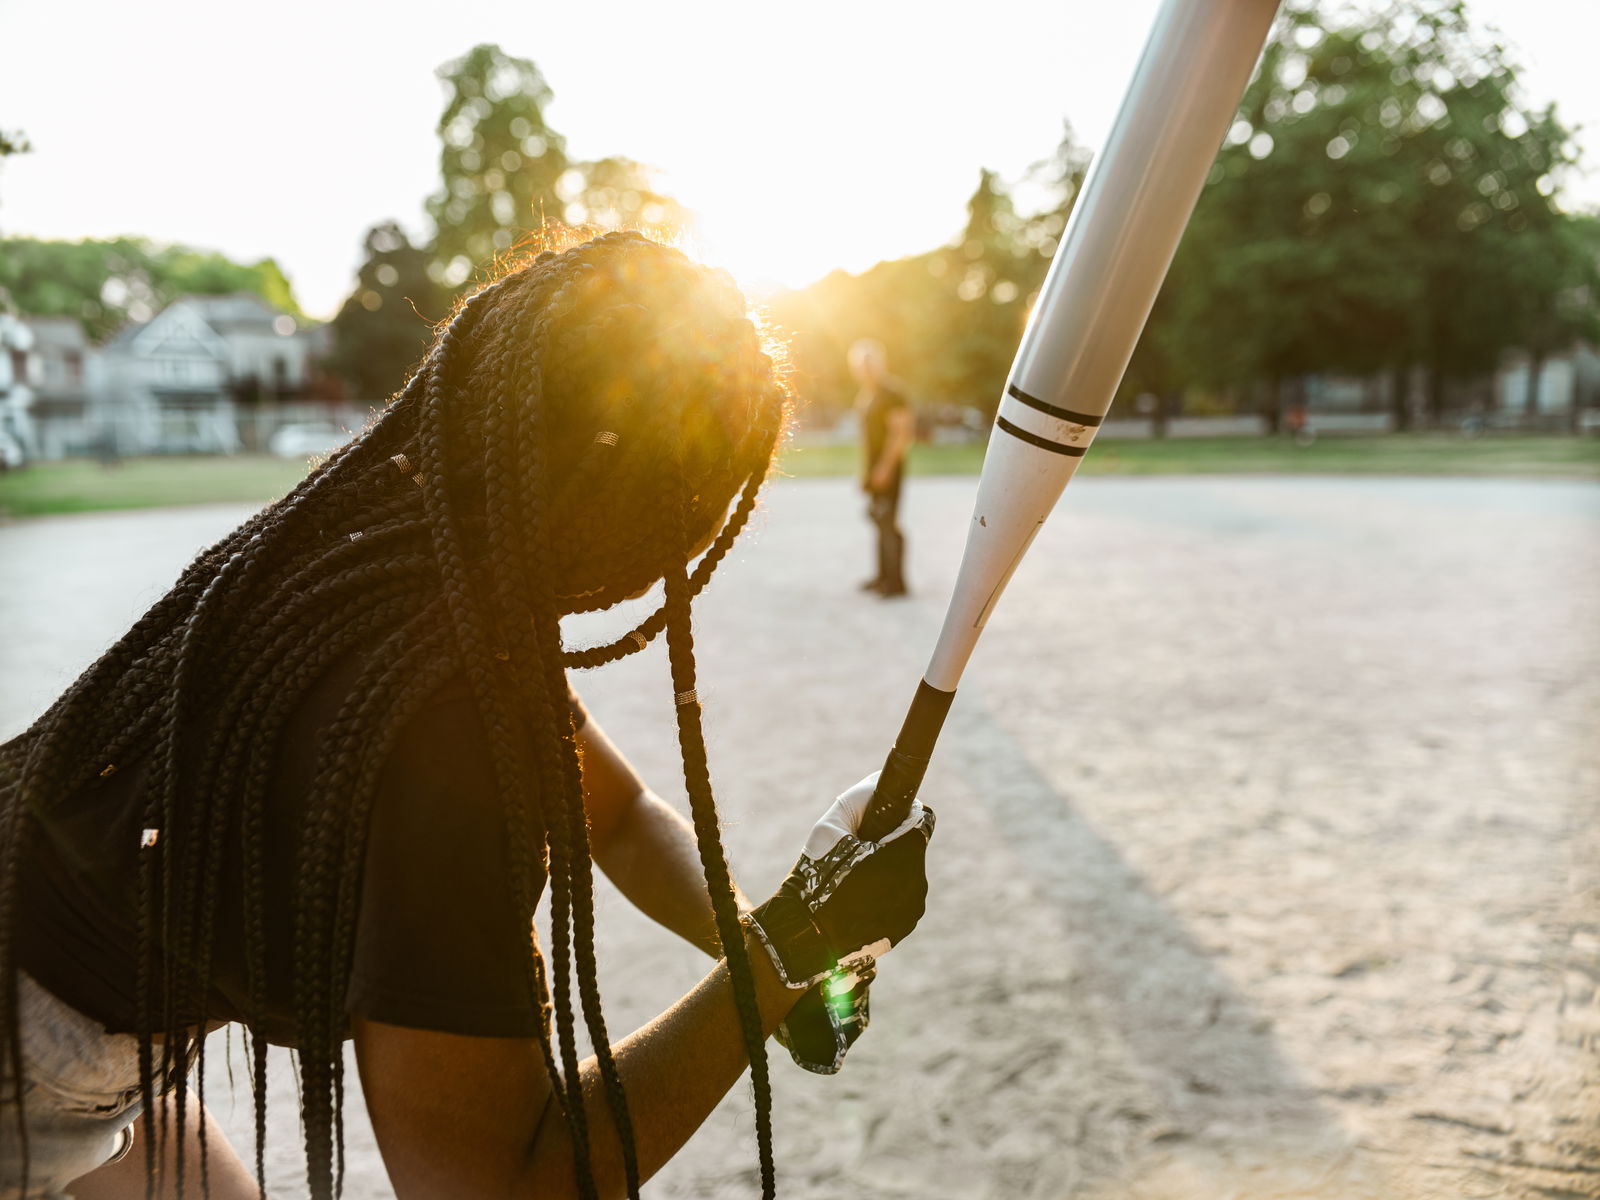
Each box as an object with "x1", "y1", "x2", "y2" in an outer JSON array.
[{"x1": 850, "y1": 338, "x2": 912, "y2": 598}]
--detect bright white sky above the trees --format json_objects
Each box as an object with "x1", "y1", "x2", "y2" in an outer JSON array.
[{"x1": 0, "y1": 0, "x2": 1600, "y2": 317}]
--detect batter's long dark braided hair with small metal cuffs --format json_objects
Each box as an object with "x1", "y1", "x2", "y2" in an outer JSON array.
[{"x1": 0, "y1": 234, "x2": 789, "y2": 1200}]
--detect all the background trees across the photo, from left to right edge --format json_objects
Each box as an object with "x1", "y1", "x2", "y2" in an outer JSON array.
[{"x1": 9, "y1": 0, "x2": 1600, "y2": 432}]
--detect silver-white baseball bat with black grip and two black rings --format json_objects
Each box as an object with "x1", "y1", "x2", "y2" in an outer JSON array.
[{"x1": 861, "y1": 0, "x2": 1278, "y2": 838}]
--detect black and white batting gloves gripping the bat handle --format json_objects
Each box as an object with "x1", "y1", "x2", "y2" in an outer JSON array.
[{"x1": 744, "y1": 773, "x2": 933, "y2": 1075}]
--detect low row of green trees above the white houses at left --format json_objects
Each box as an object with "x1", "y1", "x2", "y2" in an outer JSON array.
[{"x1": 0, "y1": 237, "x2": 299, "y2": 341}]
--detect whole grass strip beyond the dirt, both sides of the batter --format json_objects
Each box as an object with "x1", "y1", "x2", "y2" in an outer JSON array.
[{"x1": 0, "y1": 434, "x2": 1600, "y2": 517}]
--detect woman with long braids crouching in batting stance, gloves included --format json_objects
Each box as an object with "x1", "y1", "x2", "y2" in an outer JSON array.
[{"x1": 0, "y1": 235, "x2": 933, "y2": 1200}]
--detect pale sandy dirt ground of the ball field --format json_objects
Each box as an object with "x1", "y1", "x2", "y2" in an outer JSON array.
[{"x1": 0, "y1": 478, "x2": 1600, "y2": 1200}]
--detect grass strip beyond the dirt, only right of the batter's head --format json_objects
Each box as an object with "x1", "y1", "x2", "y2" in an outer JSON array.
[{"x1": 782, "y1": 434, "x2": 1600, "y2": 480}]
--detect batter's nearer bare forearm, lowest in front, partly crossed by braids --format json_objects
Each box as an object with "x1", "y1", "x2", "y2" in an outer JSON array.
[{"x1": 523, "y1": 938, "x2": 802, "y2": 1197}]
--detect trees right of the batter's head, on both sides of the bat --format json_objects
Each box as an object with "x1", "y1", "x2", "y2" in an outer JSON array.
[{"x1": 774, "y1": 0, "x2": 1600, "y2": 425}]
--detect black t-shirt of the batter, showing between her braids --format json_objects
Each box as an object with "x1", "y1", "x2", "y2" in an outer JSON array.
[{"x1": 18, "y1": 659, "x2": 586, "y2": 1045}]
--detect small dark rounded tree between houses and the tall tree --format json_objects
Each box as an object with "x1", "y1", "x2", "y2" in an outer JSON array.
[{"x1": 328, "y1": 221, "x2": 450, "y2": 402}]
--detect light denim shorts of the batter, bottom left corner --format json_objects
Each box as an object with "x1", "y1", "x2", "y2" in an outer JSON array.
[{"x1": 0, "y1": 971, "x2": 141, "y2": 1200}]
